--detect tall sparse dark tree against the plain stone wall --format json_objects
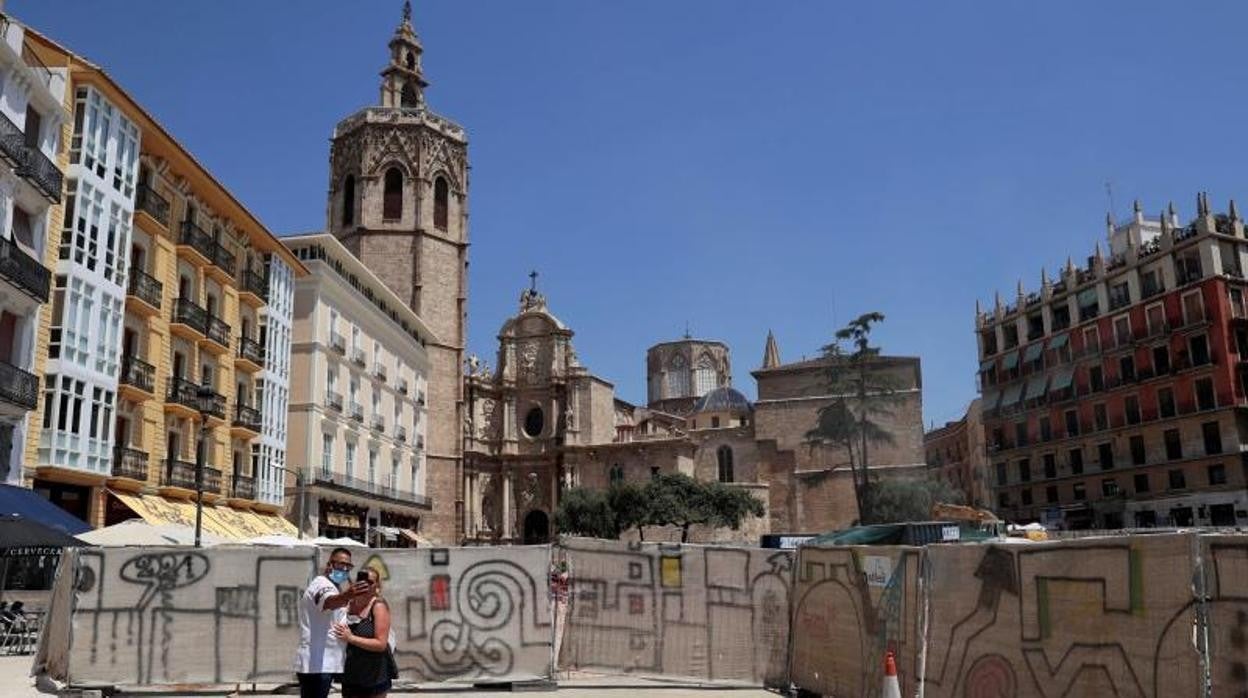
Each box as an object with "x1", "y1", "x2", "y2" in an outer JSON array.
[{"x1": 806, "y1": 312, "x2": 901, "y2": 521}]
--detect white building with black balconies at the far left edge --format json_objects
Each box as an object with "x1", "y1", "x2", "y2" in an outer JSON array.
[{"x1": 0, "y1": 16, "x2": 69, "y2": 484}]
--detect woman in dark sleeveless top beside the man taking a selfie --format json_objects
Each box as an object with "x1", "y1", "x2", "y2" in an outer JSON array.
[{"x1": 333, "y1": 567, "x2": 396, "y2": 698}]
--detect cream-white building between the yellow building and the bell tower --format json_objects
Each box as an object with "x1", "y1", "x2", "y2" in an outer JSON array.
[{"x1": 282, "y1": 233, "x2": 436, "y2": 547}]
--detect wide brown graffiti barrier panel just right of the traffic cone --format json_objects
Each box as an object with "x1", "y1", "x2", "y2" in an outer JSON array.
[{"x1": 924, "y1": 534, "x2": 1201, "y2": 698}]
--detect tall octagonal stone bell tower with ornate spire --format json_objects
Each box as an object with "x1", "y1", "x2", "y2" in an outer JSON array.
[{"x1": 327, "y1": 2, "x2": 468, "y2": 544}]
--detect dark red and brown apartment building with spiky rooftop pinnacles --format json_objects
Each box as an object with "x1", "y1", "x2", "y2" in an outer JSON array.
[{"x1": 976, "y1": 194, "x2": 1248, "y2": 528}]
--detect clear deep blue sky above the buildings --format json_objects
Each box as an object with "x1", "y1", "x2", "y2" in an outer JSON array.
[{"x1": 17, "y1": 0, "x2": 1248, "y2": 432}]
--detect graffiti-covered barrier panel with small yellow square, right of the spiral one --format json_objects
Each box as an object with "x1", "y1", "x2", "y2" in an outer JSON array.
[{"x1": 559, "y1": 538, "x2": 792, "y2": 687}]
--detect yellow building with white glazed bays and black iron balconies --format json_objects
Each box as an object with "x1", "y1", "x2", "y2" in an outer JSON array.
[{"x1": 25, "y1": 25, "x2": 307, "y2": 537}]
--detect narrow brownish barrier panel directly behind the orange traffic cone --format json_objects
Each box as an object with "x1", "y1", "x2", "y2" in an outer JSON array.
[{"x1": 790, "y1": 546, "x2": 921, "y2": 696}]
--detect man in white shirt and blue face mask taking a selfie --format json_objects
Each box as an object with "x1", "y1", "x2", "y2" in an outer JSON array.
[{"x1": 295, "y1": 548, "x2": 368, "y2": 698}]
